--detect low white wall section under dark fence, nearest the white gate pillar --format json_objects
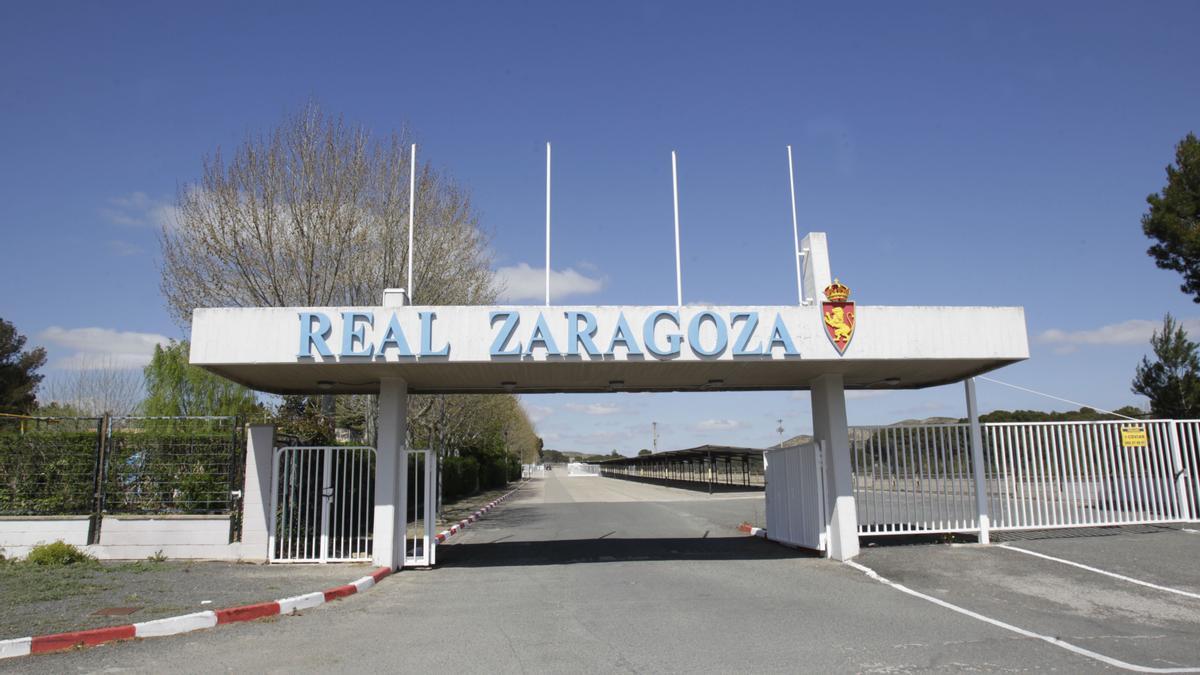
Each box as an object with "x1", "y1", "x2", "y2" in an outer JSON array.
[{"x1": 88, "y1": 515, "x2": 241, "y2": 560}]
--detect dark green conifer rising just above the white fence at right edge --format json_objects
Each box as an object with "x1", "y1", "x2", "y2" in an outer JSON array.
[{"x1": 1133, "y1": 315, "x2": 1200, "y2": 419}]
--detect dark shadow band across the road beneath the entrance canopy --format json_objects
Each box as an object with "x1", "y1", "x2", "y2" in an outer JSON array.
[{"x1": 438, "y1": 537, "x2": 821, "y2": 567}]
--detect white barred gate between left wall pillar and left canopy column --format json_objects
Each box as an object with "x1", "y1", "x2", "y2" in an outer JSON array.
[{"x1": 269, "y1": 447, "x2": 376, "y2": 562}]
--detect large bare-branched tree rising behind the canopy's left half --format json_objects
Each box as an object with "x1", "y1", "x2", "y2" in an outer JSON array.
[{"x1": 160, "y1": 103, "x2": 496, "y2": 325}]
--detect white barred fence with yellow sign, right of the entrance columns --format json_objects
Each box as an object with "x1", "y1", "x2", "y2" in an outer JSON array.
[{"x1": 850, "y1": 420, "x2": 1200, "y2": 534}]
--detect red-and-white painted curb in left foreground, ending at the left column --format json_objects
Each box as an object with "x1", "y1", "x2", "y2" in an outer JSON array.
[{"x1": 0, "y1": 562, "x2": 391, "y2": 659}]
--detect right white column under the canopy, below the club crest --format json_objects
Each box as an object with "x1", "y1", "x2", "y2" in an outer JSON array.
[{"x1": 810, "y1": 372, "x2": 858, "y2": 560}]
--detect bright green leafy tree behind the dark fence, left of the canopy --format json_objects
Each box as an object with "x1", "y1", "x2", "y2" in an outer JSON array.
[{"x1": 142, "y1": 340, "x2": 263, "y2": 417}]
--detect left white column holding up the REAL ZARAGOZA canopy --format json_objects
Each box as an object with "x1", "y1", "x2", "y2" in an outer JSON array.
[{"x1": 372, "y1": 377, "x2": 408, "y2": 569}]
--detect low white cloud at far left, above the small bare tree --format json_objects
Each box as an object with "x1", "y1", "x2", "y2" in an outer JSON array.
[{"x1": 38, "y1": 325, "x2": 168, "y2": 370}]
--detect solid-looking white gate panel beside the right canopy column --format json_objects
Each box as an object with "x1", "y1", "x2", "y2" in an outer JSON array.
[{"x1": 763, "y1": 443, "x2": 826, "y2": 551}]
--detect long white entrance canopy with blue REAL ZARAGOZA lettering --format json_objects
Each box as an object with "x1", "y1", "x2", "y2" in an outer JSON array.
[{"x1": 191, "y1": 300, "x2": 1028, "y2": 394}]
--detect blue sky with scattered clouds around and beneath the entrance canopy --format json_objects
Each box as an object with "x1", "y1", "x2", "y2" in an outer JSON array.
[{"x1": 0, "y1": 2, "x2": 1200, "y2": 452}]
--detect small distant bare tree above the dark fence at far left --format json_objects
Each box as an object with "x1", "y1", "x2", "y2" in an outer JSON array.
[{"x1": 43, "y1": 357, "x2": 143, "y2": 417}]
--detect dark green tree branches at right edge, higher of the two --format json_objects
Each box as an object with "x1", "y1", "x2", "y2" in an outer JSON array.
[{"x1": 1141, "y1": 133, "x2": 1200, "y2": 303}]
